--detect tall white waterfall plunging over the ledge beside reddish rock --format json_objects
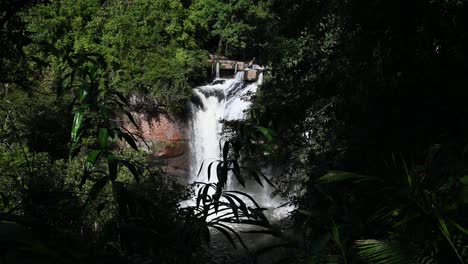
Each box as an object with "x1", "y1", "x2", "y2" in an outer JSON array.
[{"x1": 189, "y1": 71, "x2": 254, "y2": 182}]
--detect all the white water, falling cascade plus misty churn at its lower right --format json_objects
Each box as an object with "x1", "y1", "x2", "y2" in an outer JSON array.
[{"x1": 189, "y1": 70, "x2": 291, "y2": 220}]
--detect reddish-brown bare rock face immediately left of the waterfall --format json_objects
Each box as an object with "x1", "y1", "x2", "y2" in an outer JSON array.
[{"x1": 125, "y1": 113, "x2": 190, "y2": 179}]
